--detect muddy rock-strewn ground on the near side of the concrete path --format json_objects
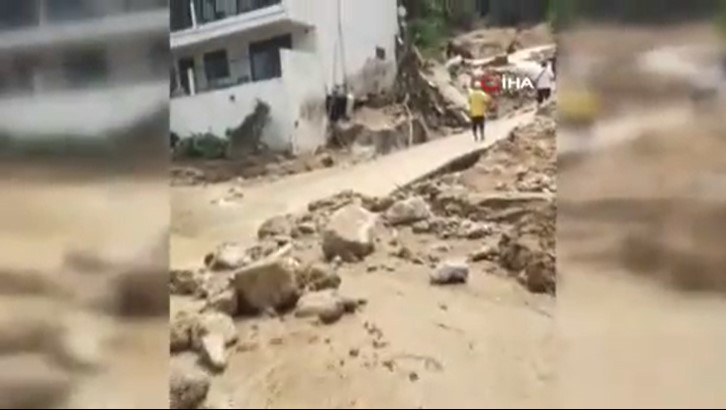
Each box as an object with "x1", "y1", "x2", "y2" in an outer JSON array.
[{"x1": 171, "y1": 107, "x2": 556, "y2": 408}]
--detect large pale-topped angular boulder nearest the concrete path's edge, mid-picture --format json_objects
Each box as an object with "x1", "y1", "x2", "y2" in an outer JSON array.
[{"x1": 322, "y1": 204, "x2": 377, "y2": 262}]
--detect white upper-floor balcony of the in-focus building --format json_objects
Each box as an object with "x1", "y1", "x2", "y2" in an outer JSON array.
[{"x1": 171, "y1": 0, "x2": 312, "y2": 49}]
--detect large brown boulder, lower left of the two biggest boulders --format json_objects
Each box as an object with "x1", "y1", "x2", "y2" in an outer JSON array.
[{"x1": 233, "y1": 254, "x2": 299, "y2": 313}]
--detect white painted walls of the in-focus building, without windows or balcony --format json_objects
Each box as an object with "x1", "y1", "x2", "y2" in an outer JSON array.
[{"x1": 171, "y1": 0, "x2": 398, "y2": 152}]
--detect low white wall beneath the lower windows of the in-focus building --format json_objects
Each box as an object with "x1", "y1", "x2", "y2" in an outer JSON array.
[{"x1": 170, "y1": 78, "x2": 294, "y2": 150}]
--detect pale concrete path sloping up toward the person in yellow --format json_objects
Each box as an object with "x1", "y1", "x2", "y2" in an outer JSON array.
[{"x1": 171, "y1": 112, "x2": 534, "y2": 267}]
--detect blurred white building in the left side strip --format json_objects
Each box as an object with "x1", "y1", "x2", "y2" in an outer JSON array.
[{"x1": 0, "y1": 0, "x2": 169, "y2": 138}]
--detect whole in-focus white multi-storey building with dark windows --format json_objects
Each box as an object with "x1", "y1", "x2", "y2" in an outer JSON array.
[{"x1": 170, "y1": 0, "x2": 398, "y2": 152}]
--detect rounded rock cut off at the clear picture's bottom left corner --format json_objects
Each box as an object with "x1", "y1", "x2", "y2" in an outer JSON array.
[{"x1": 169, "y1": 363, "x2": 210, "y2": 409}]
